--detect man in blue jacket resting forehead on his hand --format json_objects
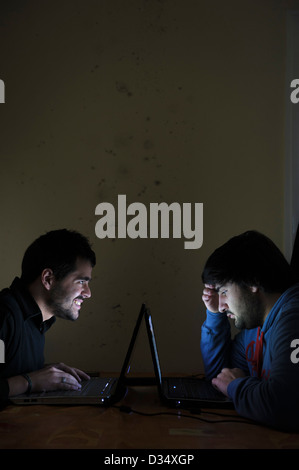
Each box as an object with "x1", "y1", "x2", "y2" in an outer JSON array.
[{"x1": 201, "y1": 231, "x2": 299, "y2": 431}]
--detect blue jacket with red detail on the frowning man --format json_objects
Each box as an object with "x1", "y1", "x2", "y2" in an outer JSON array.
[{"x1": 201, "y1": 285, "x2": 299, "y2": 431}]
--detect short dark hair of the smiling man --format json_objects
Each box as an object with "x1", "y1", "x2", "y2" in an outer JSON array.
[{"x1": 21, "y1": 229, "x2": 96, "y2": 284}]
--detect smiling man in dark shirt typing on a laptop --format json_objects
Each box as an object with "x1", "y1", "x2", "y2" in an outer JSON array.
[{"x1": 0, "y1": 229, "x2": 96, "y2": 401}]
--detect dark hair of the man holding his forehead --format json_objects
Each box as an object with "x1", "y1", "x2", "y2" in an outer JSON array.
[{"x1": 202, "y1": 230, "x2": 296, "y2": 293}]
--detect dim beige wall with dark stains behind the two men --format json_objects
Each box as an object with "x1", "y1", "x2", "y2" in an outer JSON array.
[{"x1": 0, "y1": 0, "x2": 298, "y2": 372}]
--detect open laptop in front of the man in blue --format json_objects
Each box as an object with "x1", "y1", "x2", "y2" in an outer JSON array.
[{"x1": 144, "y1": 308, "x2": 234, "y2": 410}]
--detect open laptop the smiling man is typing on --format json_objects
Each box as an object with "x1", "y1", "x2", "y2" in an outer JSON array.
[{"x1": 10, "y1": 304, "x2": 145, "y2": 406}]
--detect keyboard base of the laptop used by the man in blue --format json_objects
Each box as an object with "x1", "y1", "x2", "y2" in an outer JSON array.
[{"x1": 166, "y1": 378, "x2": 223, "y2": 400}]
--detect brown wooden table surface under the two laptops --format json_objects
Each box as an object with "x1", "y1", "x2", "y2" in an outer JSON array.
[{"x1": 0, "y1": 386, "x2": 299, "y2": 449}]
